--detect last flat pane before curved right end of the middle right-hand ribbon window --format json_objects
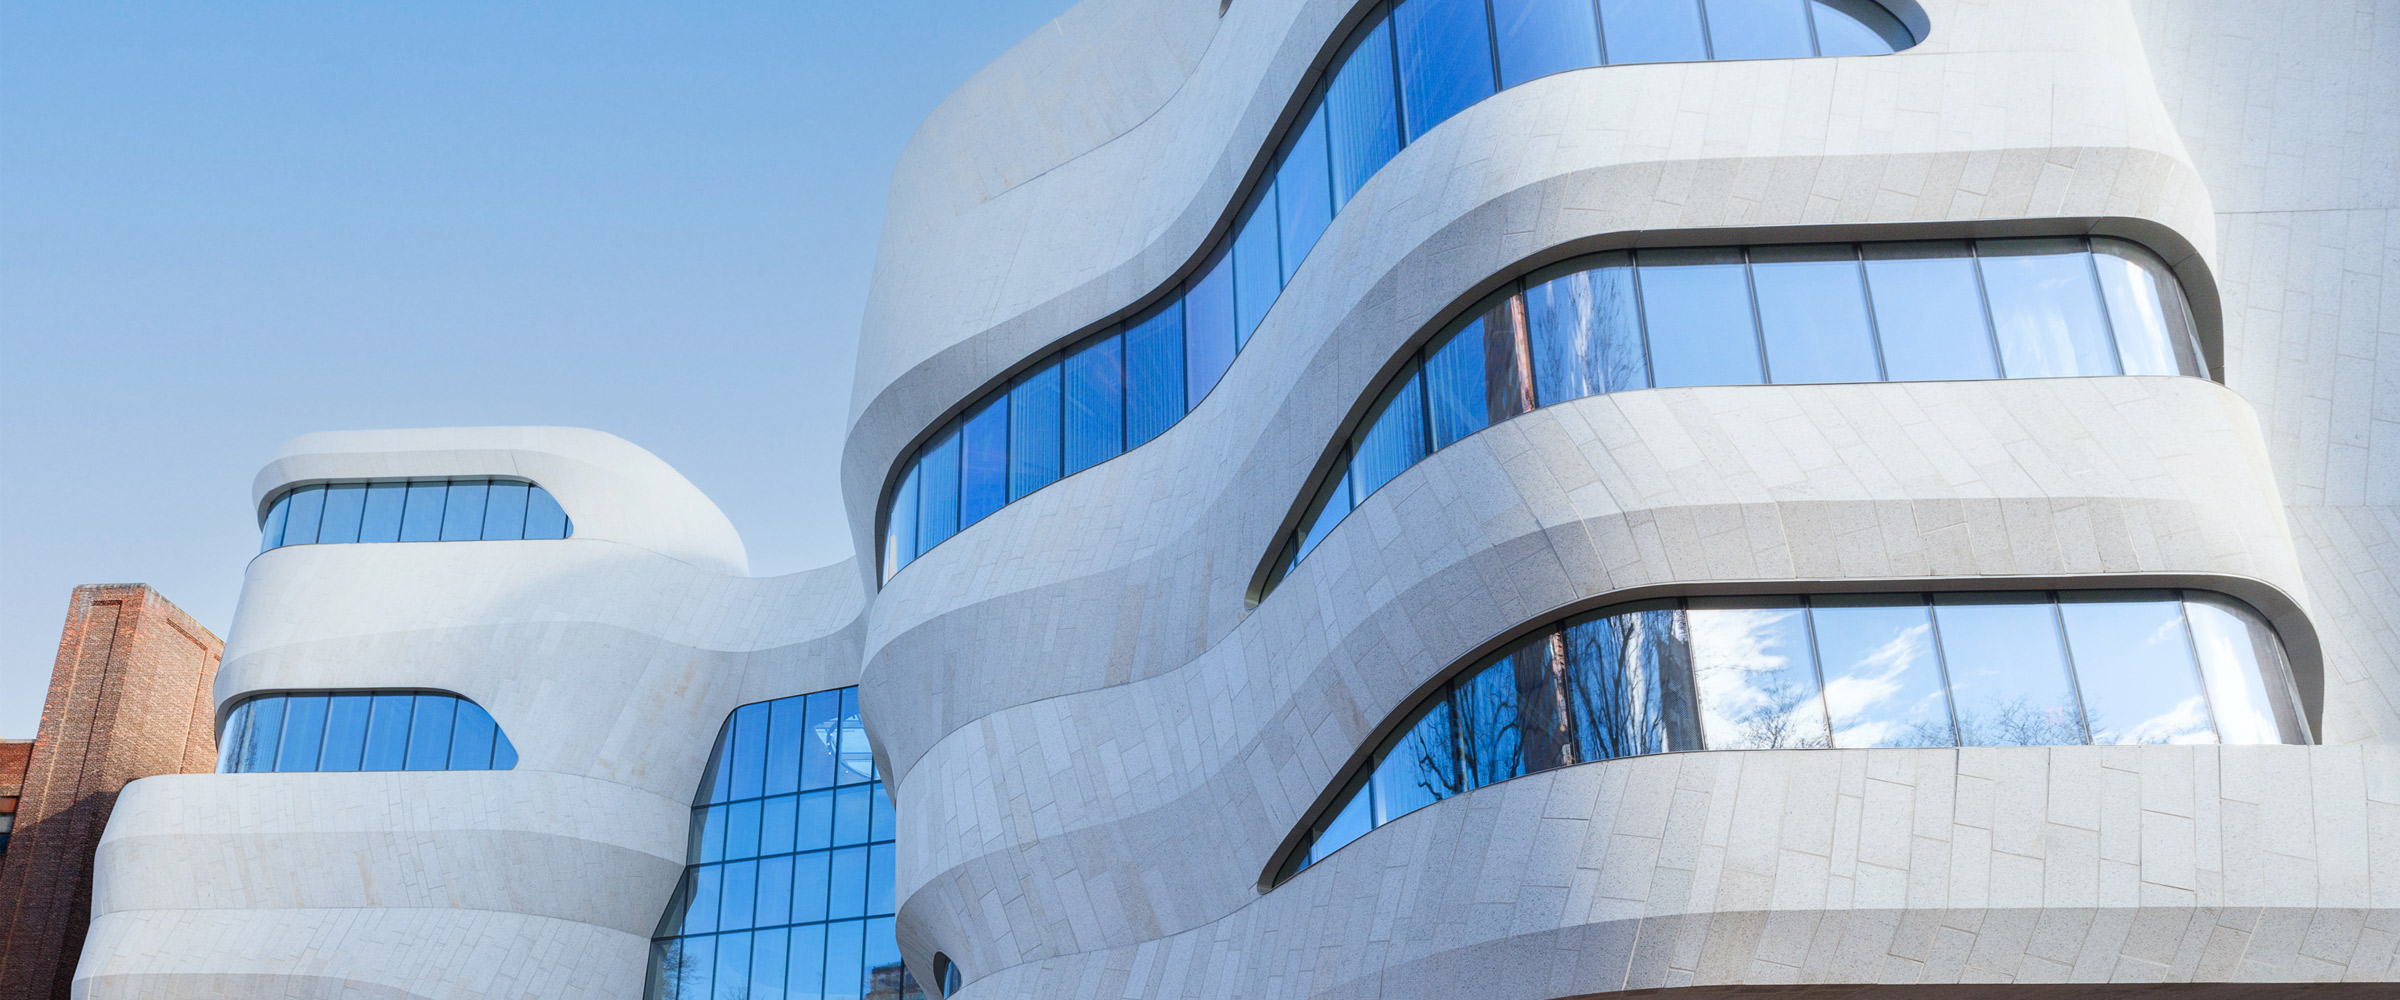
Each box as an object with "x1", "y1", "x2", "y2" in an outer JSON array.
[{"x1": 1975, "y1": 240, "x2": 2119, "y2": 379}]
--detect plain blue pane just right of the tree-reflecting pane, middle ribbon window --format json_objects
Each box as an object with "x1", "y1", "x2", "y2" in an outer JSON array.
[{"x1": 1637, "y1": 249, "x2": 1766, "y2": 386}]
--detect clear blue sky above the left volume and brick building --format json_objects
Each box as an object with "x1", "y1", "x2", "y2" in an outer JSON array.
[{"x1": 0, "y1": 0, "x2": 1068, "y2": 739}]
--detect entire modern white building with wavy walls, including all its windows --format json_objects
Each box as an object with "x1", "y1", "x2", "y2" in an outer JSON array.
[{"x1": 77, "y1": 0, "x2": 2400, "y2": 1000}]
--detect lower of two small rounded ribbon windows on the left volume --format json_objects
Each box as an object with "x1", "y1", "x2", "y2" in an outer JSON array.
[{"x1": 216, "y1": 691, "x2": 516, "y2": 775}]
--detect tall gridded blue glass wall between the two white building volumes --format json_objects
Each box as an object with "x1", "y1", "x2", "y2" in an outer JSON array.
[{"x1": 648, "y1": 688, "x2": 924, "y2": 1000}]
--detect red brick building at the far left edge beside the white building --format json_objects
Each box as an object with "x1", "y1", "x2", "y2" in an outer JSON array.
[{"x1": 0, "y1": 583, "x2": 226, "y2": 1000}]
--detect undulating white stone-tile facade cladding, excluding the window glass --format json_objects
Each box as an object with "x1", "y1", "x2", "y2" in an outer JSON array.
[{"x1": 77, "y1": 0, "x2": 2400, "y2": 1000}]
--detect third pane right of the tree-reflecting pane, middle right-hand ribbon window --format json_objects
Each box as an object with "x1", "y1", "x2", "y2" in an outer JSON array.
[{"x1": 1865, "y1": 242, "x2": 1999, "y2": 381}]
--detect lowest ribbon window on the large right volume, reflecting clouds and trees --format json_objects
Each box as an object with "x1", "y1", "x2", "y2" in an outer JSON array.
[{"x1": 1282, "y1": 590, "x2": 2309, "y2": 878}]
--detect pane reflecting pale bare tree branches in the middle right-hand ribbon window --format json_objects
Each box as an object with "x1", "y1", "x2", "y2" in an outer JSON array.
[{"x1": 1524, "y1": 252, "x2": 1649, "y2": 405}]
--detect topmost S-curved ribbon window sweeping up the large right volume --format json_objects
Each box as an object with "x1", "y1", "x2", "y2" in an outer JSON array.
[{"x1": 881, "y1": 0, "x2": 1915, "y2": 580}]
